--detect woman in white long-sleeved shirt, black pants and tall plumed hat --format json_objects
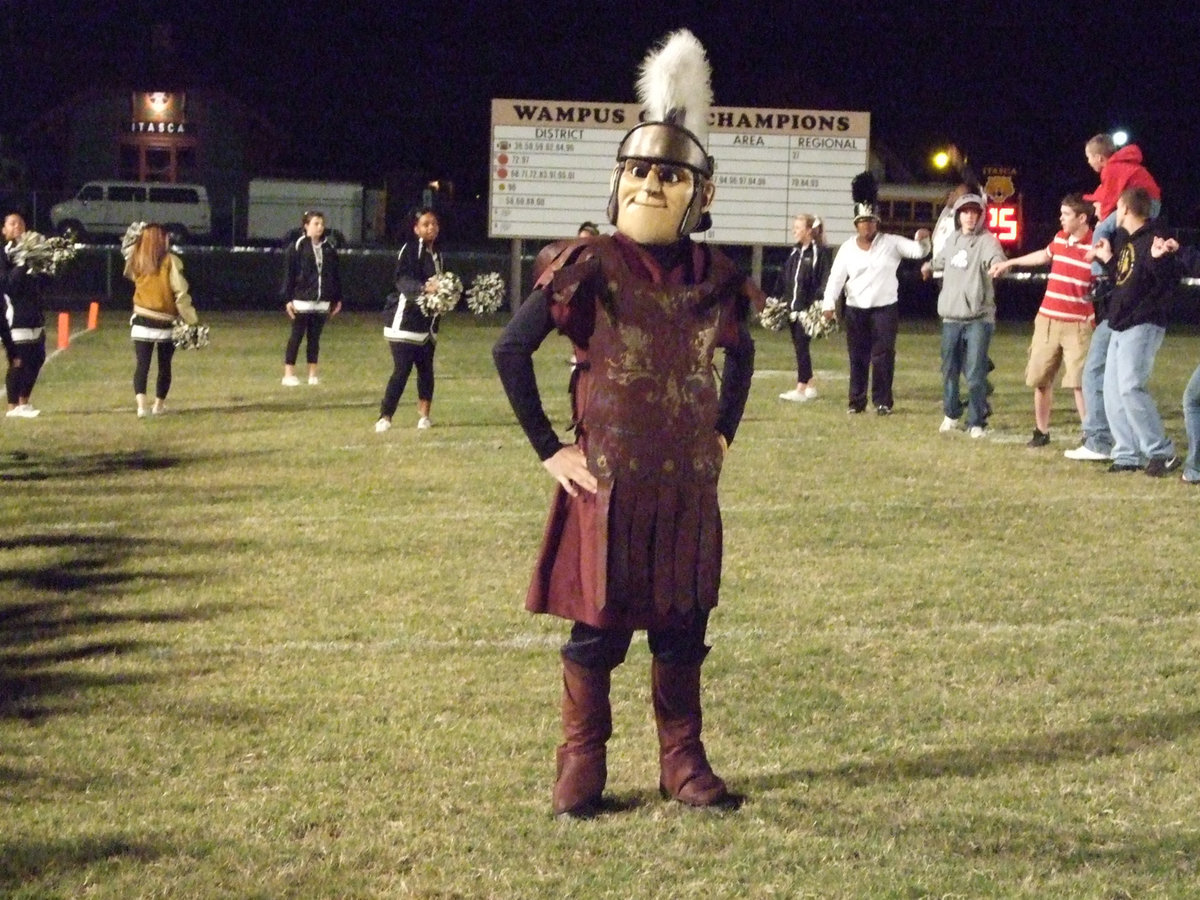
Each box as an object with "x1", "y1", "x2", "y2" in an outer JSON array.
[{"x1": 821, "y1": 173, "x2": 930, "y2": 415}]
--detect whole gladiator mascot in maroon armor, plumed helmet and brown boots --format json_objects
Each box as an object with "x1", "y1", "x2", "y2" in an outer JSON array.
[{"x1": 493, "y1": 31, "x2": 762, "y2": 818}]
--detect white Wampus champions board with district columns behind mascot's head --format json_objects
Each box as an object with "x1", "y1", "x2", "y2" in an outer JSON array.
[{"x1": 487, "y1": 100, "x2": 871, "y2": 245}]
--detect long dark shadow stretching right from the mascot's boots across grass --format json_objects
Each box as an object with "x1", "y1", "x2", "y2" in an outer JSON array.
[{"x1": 736, "y1": 709, "x2": 1200, "y2": 793}]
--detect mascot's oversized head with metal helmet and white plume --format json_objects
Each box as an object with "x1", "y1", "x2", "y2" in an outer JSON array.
[{"x1": 608, "y1": 30, "x2": 715, "y2": 245}]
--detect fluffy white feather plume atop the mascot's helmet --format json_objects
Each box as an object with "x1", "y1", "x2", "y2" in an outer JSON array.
[{"x1": 637, "y1": 29, "x2": 713, "y2": 144}]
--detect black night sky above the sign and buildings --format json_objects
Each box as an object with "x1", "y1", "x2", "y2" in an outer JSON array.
[{"x1": 7, "y1": 0, "x2": 1200, "y2": 227}]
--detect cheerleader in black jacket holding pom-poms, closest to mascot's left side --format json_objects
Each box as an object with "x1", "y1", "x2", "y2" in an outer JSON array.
[{"x1": 376, "y1": 209, "x2": 442, "y2": 432}]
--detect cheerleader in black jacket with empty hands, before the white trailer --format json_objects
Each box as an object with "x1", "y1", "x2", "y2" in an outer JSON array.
[{"x1": 282, "y1": 212, "x2": 342, "y2": 388}]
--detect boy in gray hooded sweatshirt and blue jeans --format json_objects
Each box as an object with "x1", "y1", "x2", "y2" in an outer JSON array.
[{"x1": 932, "y1": 193, "x2": 1004, "y2": 438}]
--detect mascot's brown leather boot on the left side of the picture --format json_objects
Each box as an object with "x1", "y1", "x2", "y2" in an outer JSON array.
[{"x1": 553, "y1": 658, "x2": 612, "y2": 818}]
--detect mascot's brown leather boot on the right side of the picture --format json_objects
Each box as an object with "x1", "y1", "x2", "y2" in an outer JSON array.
[{"x1": 650, "y1": 660, "x2": 733, "y2": 806}]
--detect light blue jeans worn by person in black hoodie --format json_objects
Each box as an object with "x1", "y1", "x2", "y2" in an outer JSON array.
[{"x1": 1104, "y1": 324, "x2": 1175, "y2": 466}]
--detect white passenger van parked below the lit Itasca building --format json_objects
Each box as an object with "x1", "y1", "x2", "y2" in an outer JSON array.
[{"x1": 50, "y1": 181, "x2": 212, "y2": 241}]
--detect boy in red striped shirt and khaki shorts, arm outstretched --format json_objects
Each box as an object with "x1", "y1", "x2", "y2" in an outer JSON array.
[{"x1": 990, "y1": 194, "x2": 1096, "y2": 448}]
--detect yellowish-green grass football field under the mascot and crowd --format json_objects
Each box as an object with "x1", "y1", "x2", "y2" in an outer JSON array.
[{"x1": 0, "y1": 312, "x2": 1200, "y2": 898}]
